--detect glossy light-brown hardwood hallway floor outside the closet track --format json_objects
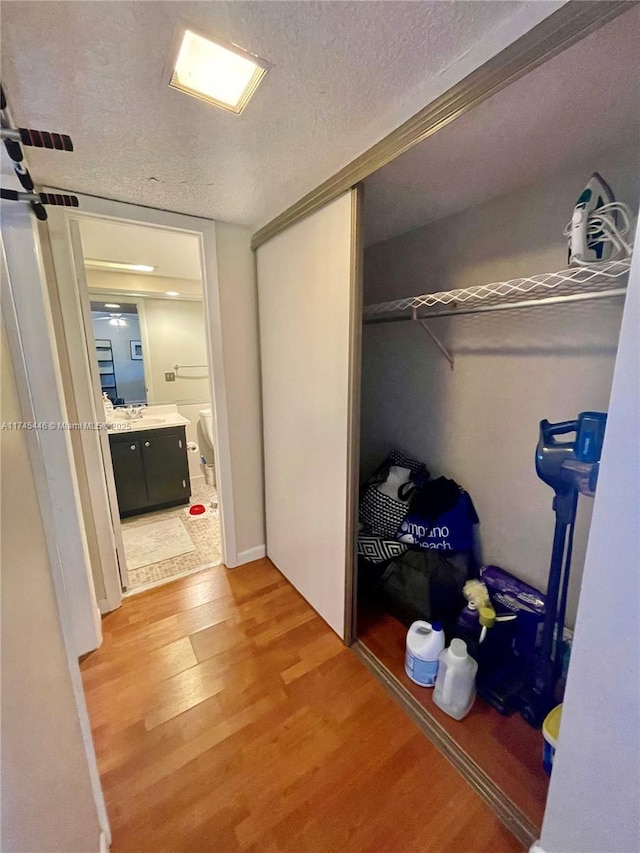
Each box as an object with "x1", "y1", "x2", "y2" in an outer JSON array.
[{"x1": 81, "y1": 560, "x2": 522, "y2": 853}]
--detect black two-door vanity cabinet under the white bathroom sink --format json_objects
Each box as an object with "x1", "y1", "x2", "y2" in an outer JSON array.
[{"x1": 109, "y1": 426, "x2": 191, "y2": 518}]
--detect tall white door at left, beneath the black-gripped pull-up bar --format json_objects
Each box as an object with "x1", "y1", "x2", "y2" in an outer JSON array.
[{"x1": 0, "y1": 202, "x2": 102, "y2": 657}]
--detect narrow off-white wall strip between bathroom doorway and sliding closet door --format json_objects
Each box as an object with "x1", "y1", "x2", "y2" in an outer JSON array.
[{"x1": 216, "y1": 222, "x2": 265, "y2": 561}]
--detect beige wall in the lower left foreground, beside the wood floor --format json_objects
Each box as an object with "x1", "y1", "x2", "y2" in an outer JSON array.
[{"x1": 1, "y1": 325, "x2": 100, "y2": 853}]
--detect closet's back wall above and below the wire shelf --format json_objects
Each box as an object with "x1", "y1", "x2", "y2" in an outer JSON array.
[{"x1": 361, "y1": 148, "x2": 640, "y2": 624}]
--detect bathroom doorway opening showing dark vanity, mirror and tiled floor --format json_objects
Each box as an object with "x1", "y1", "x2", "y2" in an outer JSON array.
[{"x1": 78, "y1": 216, "x2": 222, "y2": 594}]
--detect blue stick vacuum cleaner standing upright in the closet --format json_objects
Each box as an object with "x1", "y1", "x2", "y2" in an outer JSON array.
[{"x1": 517, "y1": 412, "x2": 607, "y2": 726}]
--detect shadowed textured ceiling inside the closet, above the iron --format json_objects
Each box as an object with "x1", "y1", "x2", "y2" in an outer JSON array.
[{"x1": 364, "y1": 7, "x2": 640, "y2": 245}]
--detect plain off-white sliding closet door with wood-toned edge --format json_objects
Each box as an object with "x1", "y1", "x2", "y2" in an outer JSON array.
[{"x1": 257, "y1": 190, "x2": 361, "y2": 641}]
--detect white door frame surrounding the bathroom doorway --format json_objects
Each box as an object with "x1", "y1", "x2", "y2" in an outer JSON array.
[{"x1": 48, "y1": 194, "x2": 237, "y2": 612}]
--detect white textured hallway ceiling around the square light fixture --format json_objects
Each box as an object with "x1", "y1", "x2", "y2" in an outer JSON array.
[{"x1": 1, "y1": 0, "x2": 562, "y2": 226}]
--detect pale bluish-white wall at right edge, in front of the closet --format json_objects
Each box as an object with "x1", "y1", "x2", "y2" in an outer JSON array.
[{"x1": 541, "y1": 216, "x2": 640, "y2": 853}]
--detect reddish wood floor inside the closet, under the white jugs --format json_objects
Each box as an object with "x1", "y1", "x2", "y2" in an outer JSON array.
[{"x1": 358, "y1": 601, "x2": 549, "y2": 828}]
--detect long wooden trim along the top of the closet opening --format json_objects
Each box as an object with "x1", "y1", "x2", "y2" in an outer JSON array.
[{"x1": 251, "y1": 0, "x2": 637, "y2": 249}]
